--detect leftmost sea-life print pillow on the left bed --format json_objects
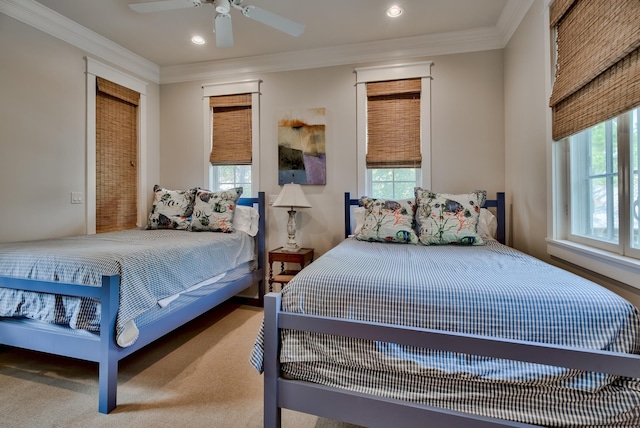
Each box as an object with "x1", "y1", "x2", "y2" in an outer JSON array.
[{"x1": 147, "y1": 184, "x2": 195, "y2": 230}]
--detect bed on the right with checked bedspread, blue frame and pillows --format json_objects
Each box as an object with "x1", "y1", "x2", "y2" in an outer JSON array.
[{"x1": 251, "y1": 193, "x2": 640, "y2": 428}]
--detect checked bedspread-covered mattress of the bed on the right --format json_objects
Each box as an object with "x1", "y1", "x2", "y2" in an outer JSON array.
[{"x1": 251, "y1": 239, "x2": 640, "y2": 427}]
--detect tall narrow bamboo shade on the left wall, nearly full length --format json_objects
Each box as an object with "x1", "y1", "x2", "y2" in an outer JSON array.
[{"x1": 96, "y1": 77, "x2": 140, "y2": 233}]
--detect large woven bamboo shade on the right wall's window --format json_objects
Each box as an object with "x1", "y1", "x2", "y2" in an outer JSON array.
[{"x1": 549, "y1": 0, "x2": 640, "y2": 141}]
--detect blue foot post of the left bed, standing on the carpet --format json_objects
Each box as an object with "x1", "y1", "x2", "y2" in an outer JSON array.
[{"x1": 98, "y1": 275, "x2": 120, "y2": 413}]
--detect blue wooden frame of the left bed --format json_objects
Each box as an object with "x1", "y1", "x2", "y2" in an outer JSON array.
[{"x1": 0, "y1": 192, "x2": 266, "y2": 413}]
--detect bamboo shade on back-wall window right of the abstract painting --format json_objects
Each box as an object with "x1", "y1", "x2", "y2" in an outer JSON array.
[{"x1": 367, "y1": 79, "x2": 422, "y2": 168}]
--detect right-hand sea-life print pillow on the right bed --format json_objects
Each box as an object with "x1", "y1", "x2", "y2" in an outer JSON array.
[{"x1": 415, "y1": 187, "x2": 487, "y2": 245}]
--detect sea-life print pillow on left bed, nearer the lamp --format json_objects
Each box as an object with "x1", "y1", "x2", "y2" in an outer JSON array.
[{"x1": 191, "y1": 187, "x2": 242, "y2": 232}]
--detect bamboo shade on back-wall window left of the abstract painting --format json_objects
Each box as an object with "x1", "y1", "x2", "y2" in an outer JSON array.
[{"x1": 209, "y1": 94, "x2": 252, "y2": 165}]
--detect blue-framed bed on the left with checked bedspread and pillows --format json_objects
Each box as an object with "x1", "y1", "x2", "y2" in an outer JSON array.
[{"x1": 0, "y1": 189, "x2": 265, "y2": 413}]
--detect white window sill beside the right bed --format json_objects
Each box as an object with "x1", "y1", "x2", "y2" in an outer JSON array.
[{"x1": 547, "y1": 239, "x2": 640, "y2": 289}]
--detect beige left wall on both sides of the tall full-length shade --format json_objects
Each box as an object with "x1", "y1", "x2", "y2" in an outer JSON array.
[{"x1": 0, "y1": 14, "x2": 160, "y2": 242}]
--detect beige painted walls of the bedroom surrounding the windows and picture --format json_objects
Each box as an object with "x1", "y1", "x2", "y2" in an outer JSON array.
[{"x1": 0, "y1": 0, "x2": 640, "y2": 305}]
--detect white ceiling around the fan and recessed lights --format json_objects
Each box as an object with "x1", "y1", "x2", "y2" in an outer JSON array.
[{"x1": 32, "y1": 0, "x2": 521, "y2": 66}]
